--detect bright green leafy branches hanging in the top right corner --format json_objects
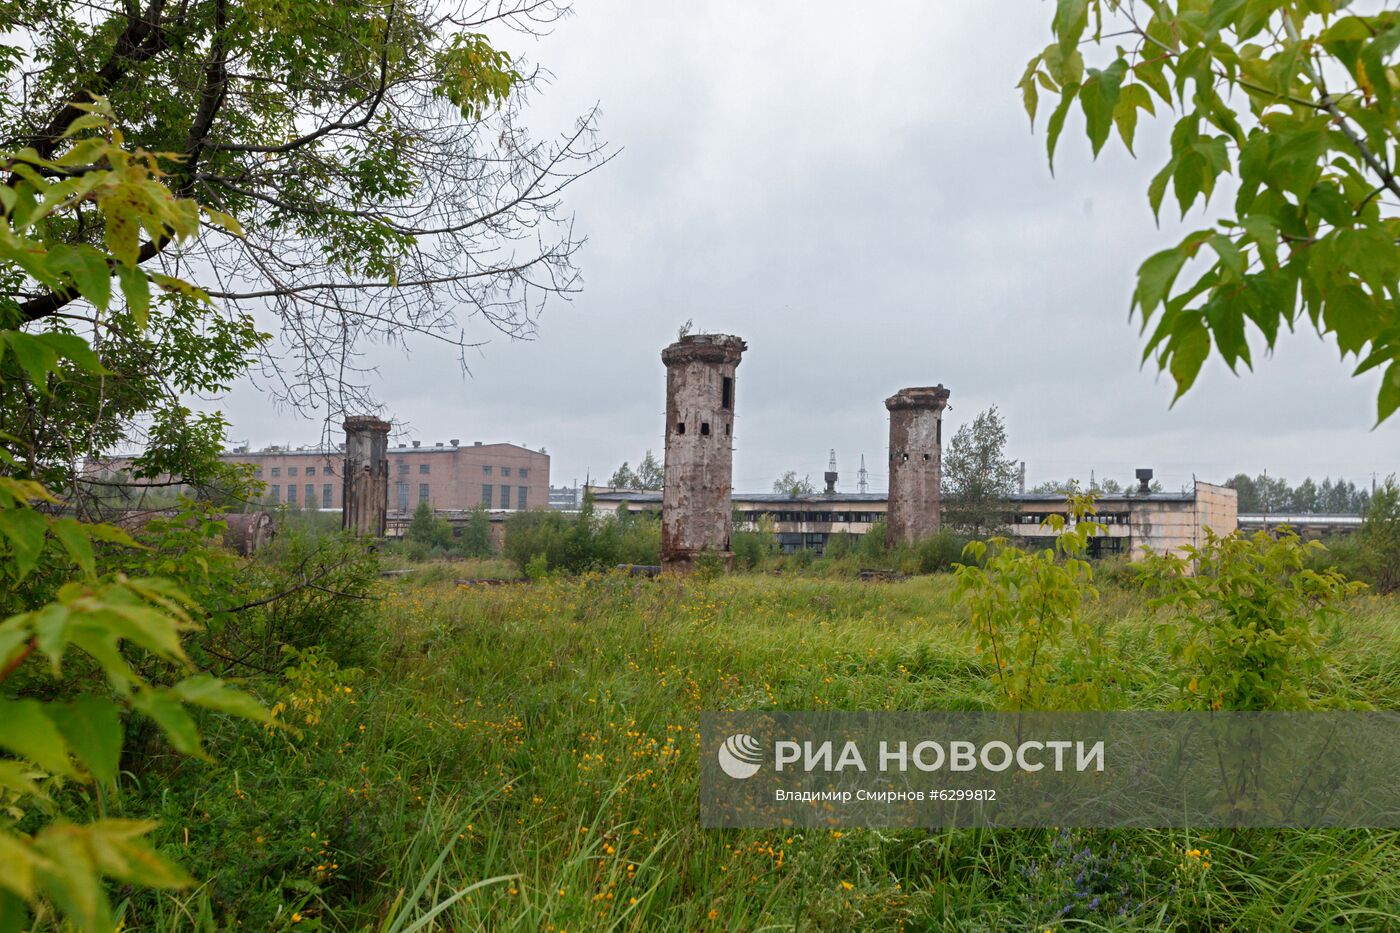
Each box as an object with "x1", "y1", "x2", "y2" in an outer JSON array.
[{"x1": 1019, "y1": 0, "x2": 1400, "y2": 422}]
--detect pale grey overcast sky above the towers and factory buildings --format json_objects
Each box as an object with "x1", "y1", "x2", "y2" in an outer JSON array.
[{"x1": 203, "y1": 0, "x2": 1400, "y2": 492}]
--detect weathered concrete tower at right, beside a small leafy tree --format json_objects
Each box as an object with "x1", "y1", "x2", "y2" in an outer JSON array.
[{"x1": 885, "y1": 385, "x2": 948, "y2": 546}]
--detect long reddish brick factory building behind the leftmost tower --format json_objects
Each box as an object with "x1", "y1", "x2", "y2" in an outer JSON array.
[{"x1": 85, "y1": 441, "x2": 549, "y2": 516}]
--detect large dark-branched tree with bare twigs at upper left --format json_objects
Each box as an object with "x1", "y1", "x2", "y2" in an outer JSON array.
[{"x1": 0, "y1": 0, "x2": 605, "y2": 481}]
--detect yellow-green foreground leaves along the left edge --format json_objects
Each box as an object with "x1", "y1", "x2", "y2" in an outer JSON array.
[{"x1": 0, "y1": 99, "x2": 269, "y2": 930}]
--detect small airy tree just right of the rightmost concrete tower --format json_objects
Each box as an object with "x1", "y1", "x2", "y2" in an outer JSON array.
[{"x1": 942, "y1": 405, "x2": 1019, "y2": 535}]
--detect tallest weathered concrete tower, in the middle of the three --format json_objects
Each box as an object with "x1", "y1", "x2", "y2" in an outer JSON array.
[{"x1": 661, "y1": 333, "x2": 748, "y2": 573}]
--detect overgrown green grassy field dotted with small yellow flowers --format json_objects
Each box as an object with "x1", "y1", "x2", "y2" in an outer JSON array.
[{"x1": 123, "y1": 567, "x2": 1400, "y2": 932}]
